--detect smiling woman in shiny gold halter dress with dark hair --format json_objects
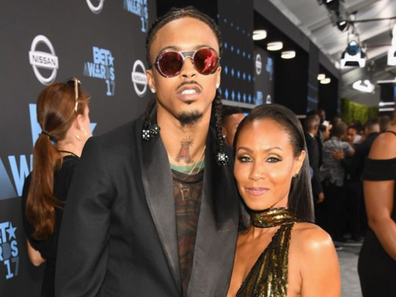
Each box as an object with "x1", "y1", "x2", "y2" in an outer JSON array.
[{"x1": 227, "y1": 104, "x2": 341, "y2": 297}]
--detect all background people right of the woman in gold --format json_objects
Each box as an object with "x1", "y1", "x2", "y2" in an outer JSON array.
[{"x1": 304, "y1": 110, "x2": 396, "y2": 297}]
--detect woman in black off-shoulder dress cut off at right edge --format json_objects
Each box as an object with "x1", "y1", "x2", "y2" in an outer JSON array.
[{"x1": 358, "y1": 112, "x2": 396, "y2": 297}]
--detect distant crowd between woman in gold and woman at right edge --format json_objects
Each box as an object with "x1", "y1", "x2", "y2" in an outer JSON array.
[{"x1": 303, "y1": 110, "x2": 380, "y2": 243}]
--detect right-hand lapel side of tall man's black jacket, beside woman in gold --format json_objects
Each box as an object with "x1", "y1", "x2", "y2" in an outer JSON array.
[{"x1": 187, "y1": 132, "x2": 239, "y2": 297}]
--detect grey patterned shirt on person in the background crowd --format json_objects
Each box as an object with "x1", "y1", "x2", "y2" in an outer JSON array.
[{"x1": 320, "y1": 136, "x2": 353, "y2": 187}]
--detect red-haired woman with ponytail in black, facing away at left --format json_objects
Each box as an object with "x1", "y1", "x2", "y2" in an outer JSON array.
[{"x1": 22, "y1": 78, "x2": 91, "y2": 297}]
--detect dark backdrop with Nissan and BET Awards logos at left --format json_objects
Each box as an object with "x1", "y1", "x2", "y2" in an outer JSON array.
[{"x1": 0, "y1": 0, "x2": 156, "y2": 297}]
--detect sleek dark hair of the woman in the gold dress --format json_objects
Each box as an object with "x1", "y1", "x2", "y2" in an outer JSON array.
[{"x1": 234, "y1": 104, "x2": 315, "y2": 225}]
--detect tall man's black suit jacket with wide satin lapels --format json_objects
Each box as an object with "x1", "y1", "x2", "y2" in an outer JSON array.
[{"x1": 55, "y1": 120, "x2": 239, "y2": 297}]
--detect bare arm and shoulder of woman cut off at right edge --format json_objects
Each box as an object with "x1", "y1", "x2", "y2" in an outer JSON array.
[{"x1": 364, "y1": 133, "x2": 396, "y2": 261}]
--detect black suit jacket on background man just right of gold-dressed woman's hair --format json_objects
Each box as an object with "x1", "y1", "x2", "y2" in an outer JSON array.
[{"x1": 304, "y1": 133, "x2": 323, "y2": 199}]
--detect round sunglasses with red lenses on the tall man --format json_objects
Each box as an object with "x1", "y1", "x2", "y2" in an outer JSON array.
[{"x1": 149, "y1": 47, "x2": 220, "y2": 78}]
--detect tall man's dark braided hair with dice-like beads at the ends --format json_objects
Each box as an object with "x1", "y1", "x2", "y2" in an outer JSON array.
[{"x1": 143, "y1": 6, "x2": 228, "y2": 165}]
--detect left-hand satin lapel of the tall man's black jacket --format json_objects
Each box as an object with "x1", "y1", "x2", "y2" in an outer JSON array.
[{"x1": 140, "y1": 121, "x2": 181, "y2": 291}]
